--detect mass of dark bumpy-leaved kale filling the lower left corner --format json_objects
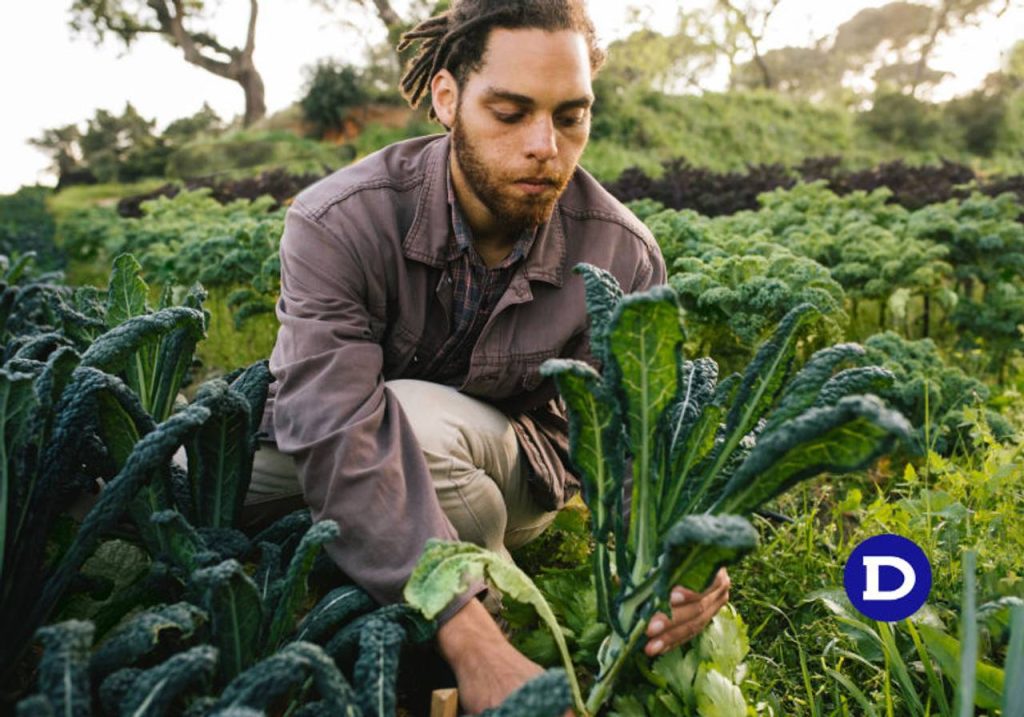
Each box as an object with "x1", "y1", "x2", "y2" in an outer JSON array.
[{"x1": 0, "y1": 255, "x2": 456, "y2": 715}]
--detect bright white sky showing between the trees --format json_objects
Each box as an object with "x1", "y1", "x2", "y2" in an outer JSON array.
[{"x1": 0, "y1": 0, "x2": 1024, "y2": 194}]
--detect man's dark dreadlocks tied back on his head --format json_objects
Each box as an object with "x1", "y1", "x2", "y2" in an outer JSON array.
[{"x1": 398, "y1": 0, "x2": 605, "y2": 120}]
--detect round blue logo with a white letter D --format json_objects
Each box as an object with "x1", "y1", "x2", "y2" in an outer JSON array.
[{"x1": 843, "y1": 534, "x2": 932, "y2": 623}]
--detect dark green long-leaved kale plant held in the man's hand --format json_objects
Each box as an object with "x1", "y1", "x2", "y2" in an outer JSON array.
[{"x1": 404, "y1": 265, "x2": 910, "y2": 715}]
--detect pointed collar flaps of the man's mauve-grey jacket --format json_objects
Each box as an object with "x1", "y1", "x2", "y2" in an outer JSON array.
[{"x1": 401, "y1": 134, "x2": 575, "y2": 287}]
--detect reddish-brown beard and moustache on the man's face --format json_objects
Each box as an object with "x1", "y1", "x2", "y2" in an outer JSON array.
[{"x1": 452, "y1": 114, "x2": 572, "y2": 231}]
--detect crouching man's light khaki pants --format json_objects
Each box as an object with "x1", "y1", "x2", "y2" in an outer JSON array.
[{"x1": 240, "y1": 379, "x2": 557, "y2": 558}]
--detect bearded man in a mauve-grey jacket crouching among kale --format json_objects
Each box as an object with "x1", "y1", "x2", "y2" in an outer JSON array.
[{"x1": 260, "y1": 0, "x2": 729, "y2": 713}]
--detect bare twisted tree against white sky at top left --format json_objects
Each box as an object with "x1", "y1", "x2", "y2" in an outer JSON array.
[{"x1": 71, "y1": 0, "x2": 266, "y2": 126}]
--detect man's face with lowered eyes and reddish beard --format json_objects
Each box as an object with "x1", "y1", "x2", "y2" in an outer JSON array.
[{"x1": 452, "y1": 30, "x2": 593, "y2": 228}]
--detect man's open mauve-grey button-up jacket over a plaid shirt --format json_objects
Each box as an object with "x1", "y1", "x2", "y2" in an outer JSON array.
[{"x1": 262, "y1": 135, "x2": 666, "y2": 613}]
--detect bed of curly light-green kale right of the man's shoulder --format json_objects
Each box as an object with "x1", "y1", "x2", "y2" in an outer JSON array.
[{"x1": 639, "y1": 181, "x2": 1024, "y2": 381}]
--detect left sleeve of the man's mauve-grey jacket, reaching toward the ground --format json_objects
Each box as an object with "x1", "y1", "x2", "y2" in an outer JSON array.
[{"x1": 270, "y1": 203, "x2": 483, "y2": 621}]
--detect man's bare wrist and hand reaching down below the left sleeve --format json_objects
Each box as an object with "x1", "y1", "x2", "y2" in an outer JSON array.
[{"x1": 437, "y1": 599, "x2": 572, "y2": 715}]
